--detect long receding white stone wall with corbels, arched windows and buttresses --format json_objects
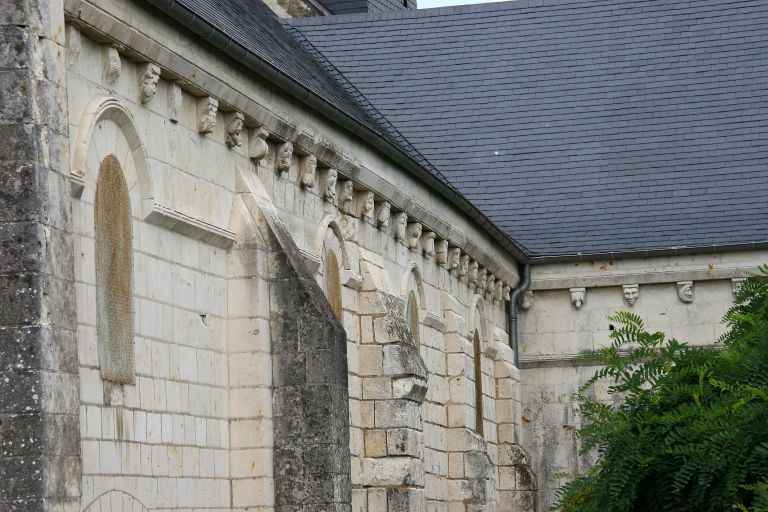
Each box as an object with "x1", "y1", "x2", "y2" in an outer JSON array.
[{"x1": 61, "y1": 1, "x2": 535, "y2": 512}]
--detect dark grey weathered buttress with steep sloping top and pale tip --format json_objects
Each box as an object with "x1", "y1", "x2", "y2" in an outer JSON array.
[{"x1": 238, "y1": 171, "x2": 352, "y2": 512}]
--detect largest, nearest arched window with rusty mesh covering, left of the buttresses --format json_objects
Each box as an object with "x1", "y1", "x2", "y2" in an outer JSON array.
[{"x1": 94, "y1": 155, "x2": 134, "y2": 384}]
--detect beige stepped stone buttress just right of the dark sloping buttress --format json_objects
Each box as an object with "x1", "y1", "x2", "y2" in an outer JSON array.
[{"x1": 359, "y1": 268, "x2": 427, "y2": 512}]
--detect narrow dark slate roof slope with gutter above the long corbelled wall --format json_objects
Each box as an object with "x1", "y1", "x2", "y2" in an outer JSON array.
[{"x1": 147, "y1": 0, "x2": 526, "y2": 259}]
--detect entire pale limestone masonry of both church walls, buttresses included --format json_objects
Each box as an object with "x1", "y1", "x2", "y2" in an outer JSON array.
[{"x1": 0, "y1": 0, "x2": 768, "y2": 512}]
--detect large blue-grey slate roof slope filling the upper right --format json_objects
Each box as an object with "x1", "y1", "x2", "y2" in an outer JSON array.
[{"x1": 291, "y1": 0, "x2": 768, "y2": 257}]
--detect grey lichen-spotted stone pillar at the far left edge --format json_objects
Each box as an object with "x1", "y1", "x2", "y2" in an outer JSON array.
[{"x1": 0, "y1": 0, "x2": 81, "y2": 512}]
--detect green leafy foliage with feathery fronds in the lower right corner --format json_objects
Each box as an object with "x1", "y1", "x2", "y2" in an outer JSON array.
[{"x1": 556, "y1": 267, "x2": 768, "y2": 512}]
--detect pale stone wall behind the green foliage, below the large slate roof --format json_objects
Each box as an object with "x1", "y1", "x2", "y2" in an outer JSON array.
[{"x1": 520, "y1": 251, "x2": 768, "y2": 510}]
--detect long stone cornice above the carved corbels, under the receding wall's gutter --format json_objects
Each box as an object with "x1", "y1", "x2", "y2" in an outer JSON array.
[{"x1": 65, "y1": 0, "x2": 519, "y2": 292}]
